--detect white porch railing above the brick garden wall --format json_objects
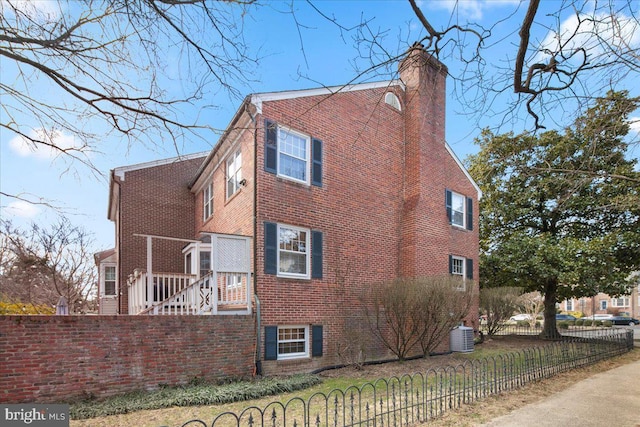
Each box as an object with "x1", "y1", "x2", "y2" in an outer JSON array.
[{"x1": 129, "y1": 271, "x2": 251, "y2": 315}]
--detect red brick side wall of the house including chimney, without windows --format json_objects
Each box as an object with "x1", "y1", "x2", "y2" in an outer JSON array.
[{"x1": 255, "y1": 51, "x2": 478, "y2": 374}]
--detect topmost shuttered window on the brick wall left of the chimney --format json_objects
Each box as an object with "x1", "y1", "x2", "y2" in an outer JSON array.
[{"x1": 264, "y1": 120, "x2": 322, "y2": 187}]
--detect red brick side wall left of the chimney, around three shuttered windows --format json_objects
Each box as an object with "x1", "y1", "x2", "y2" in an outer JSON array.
[{"x1": 256, "y1": 87, "x2": 403, "y2": 373}]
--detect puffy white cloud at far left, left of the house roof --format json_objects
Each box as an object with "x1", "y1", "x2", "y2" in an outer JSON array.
[{"x1": 9, "y1": 129, "x2": 83, "y2": 159}]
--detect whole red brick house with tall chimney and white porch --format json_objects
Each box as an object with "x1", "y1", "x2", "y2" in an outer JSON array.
[{"x1": 97, "y1": 46, "x2": 480, "y2": 374}]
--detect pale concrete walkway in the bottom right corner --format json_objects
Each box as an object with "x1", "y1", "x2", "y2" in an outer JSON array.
[{"x1": 481, "y1": 358, "x2": 640, "y2": 427}]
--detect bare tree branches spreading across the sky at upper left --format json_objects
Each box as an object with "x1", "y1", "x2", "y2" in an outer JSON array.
[{"x1": 0, "y1": 0, "x2": 256, "y2": 206}]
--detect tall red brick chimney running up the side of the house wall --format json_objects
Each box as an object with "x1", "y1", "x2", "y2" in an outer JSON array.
[{"x1": 399, "y1": 44, "x2": 450, "y2": 277}]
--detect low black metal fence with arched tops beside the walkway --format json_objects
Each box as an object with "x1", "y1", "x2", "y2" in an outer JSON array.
[{"x1": 171, "y1": 329, "x2": 633, "y2": 427}]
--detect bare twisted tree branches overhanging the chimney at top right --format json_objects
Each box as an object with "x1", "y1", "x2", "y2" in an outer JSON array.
[{"x1": 306, "y1": 0, "x2": 640, "y2": 135}]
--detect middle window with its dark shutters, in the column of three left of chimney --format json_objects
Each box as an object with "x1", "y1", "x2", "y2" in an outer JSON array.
[{"x1": 264, "y1": 222, "x2": 323, "y2": 279}]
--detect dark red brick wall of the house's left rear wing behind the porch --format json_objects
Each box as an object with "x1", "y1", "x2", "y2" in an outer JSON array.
[{"x1": 116, "y1": 158, "x2": 203, "y2": 314}]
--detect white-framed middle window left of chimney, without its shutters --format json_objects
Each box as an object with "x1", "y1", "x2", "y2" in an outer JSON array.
[{"x1": 278, "y1": 224, "x2": 311, "y2": 278}]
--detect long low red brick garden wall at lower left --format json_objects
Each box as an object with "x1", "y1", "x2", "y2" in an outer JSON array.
[{"x1": 0, "y1": 316, "x2": 255, "y2": 403}]
